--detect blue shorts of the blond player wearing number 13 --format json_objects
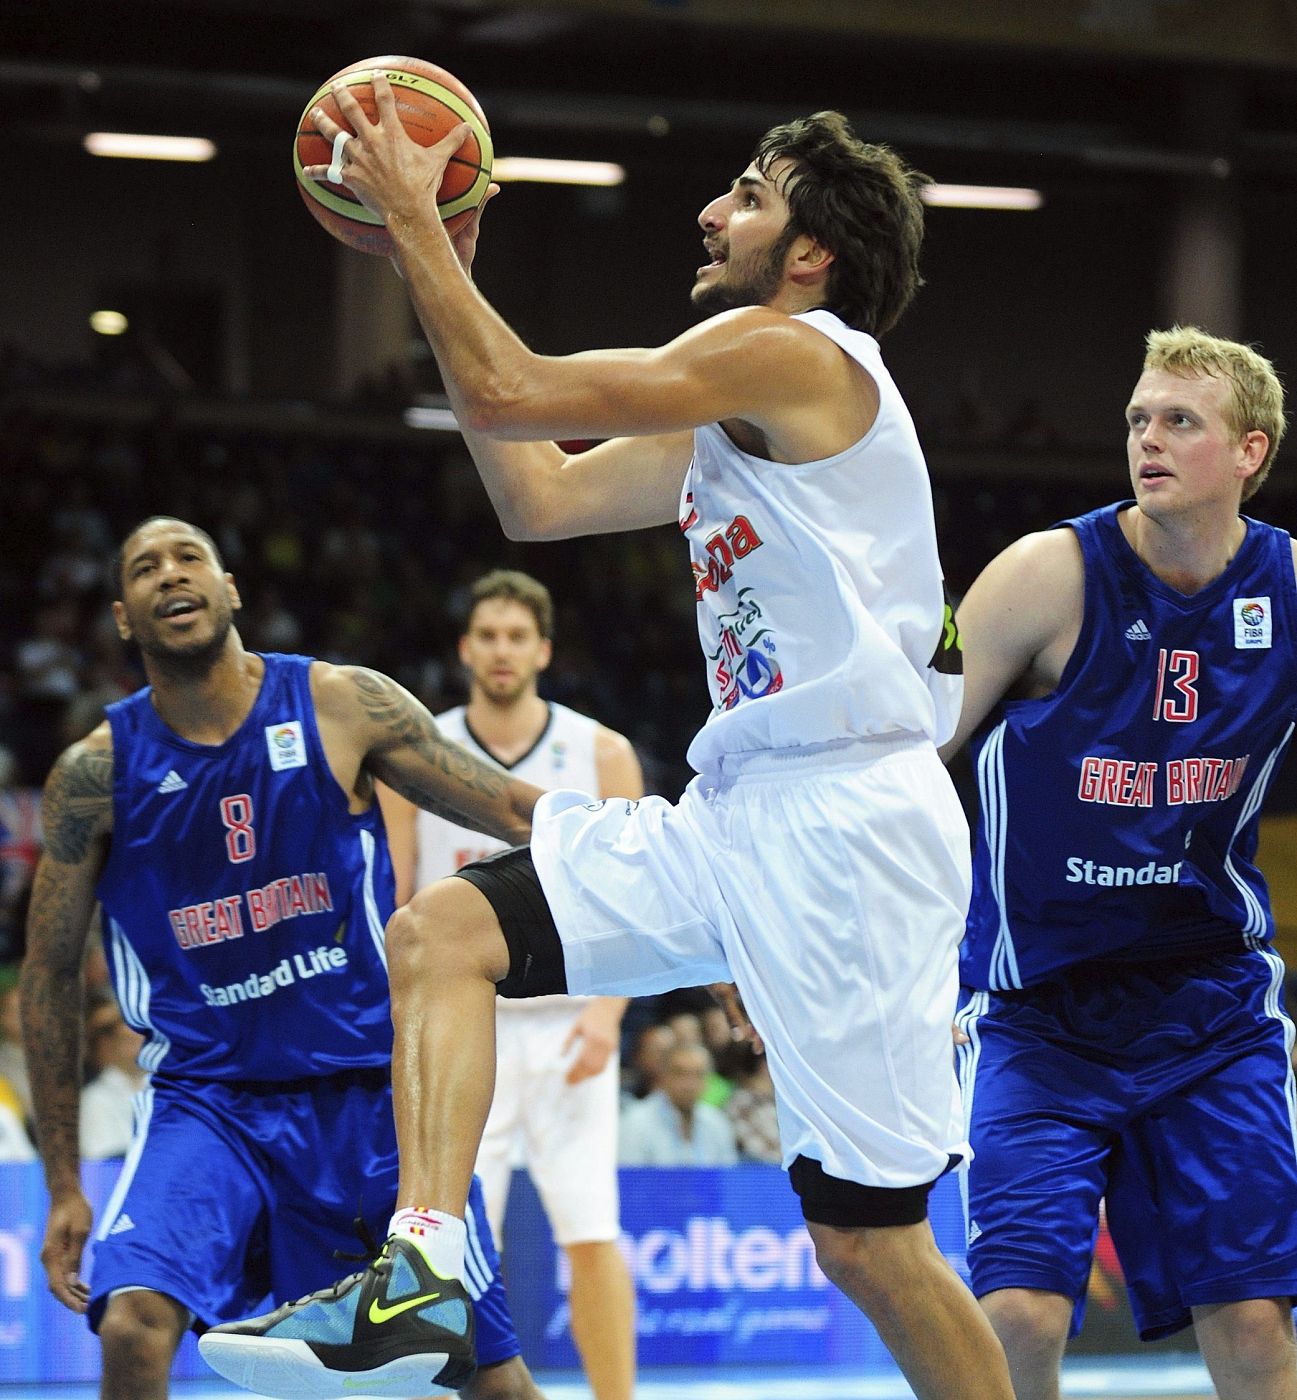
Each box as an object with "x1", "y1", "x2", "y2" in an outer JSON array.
[{"x1": 957, "y1": 951, "x2": 1297, "y2": 1341}]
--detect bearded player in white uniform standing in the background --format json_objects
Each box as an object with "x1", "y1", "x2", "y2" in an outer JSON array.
[{"x1": 381, "y1": 568, "x2": 644, "y2": 1400}]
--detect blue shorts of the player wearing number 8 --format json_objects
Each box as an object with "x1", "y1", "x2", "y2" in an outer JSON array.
[{"x1": 90, "y1": 1071, "x2": 518, "y2": 1366}]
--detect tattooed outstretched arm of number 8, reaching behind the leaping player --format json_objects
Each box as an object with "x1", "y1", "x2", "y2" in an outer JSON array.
[{"x1": 311, "y1": 661, "x2": 541, "y2": 846}]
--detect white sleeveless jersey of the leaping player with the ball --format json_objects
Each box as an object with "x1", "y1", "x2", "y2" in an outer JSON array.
[{"x1": 681, "y1": 303, "x2": 964, "y2": 773}]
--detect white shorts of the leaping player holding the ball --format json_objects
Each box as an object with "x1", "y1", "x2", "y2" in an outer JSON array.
[{"x1": 531, "y1": 736, "x2": 971, "y2": 1189}]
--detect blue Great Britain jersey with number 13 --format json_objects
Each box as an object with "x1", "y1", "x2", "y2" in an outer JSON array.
[{"x1": 961, "y1": 501, "x2": 1297, "y2": 991}]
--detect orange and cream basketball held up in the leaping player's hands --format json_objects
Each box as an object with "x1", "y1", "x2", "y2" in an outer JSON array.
[{"x1": 293, "y1": 56, "x2": 493, "y2": 258}]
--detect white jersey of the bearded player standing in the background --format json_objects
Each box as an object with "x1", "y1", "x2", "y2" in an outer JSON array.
[{"x1": 415, "y1": 704, "x2": 599, "y2": 1015}]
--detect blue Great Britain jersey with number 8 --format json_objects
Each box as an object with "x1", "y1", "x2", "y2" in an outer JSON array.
[{"x1": 98, "y1": 655, "x2": 395, "y2": 1082}]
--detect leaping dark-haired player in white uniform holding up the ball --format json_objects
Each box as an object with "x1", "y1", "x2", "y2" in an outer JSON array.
[{"x1": 208, "y1": 98, "x2": 1011, "y2": 1400}]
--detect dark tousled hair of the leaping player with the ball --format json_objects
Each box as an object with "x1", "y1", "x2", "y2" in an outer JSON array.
[{"x1": 752, "y1": 112, "x2": 931, "y2": 336}]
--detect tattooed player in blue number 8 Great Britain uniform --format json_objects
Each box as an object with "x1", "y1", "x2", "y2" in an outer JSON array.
[{"x1": 22, "y1": 517, "x2": 539, "y2": 1400}]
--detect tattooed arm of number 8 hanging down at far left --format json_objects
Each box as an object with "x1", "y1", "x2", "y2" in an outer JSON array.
[{"x1": 20, "y1": 724, "x2": 112, "y2": 1312}]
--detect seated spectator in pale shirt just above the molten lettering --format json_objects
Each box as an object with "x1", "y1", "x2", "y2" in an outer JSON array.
[{"x1": 618, "y1": 1043, "x2": 738, "y2": 1166}]
